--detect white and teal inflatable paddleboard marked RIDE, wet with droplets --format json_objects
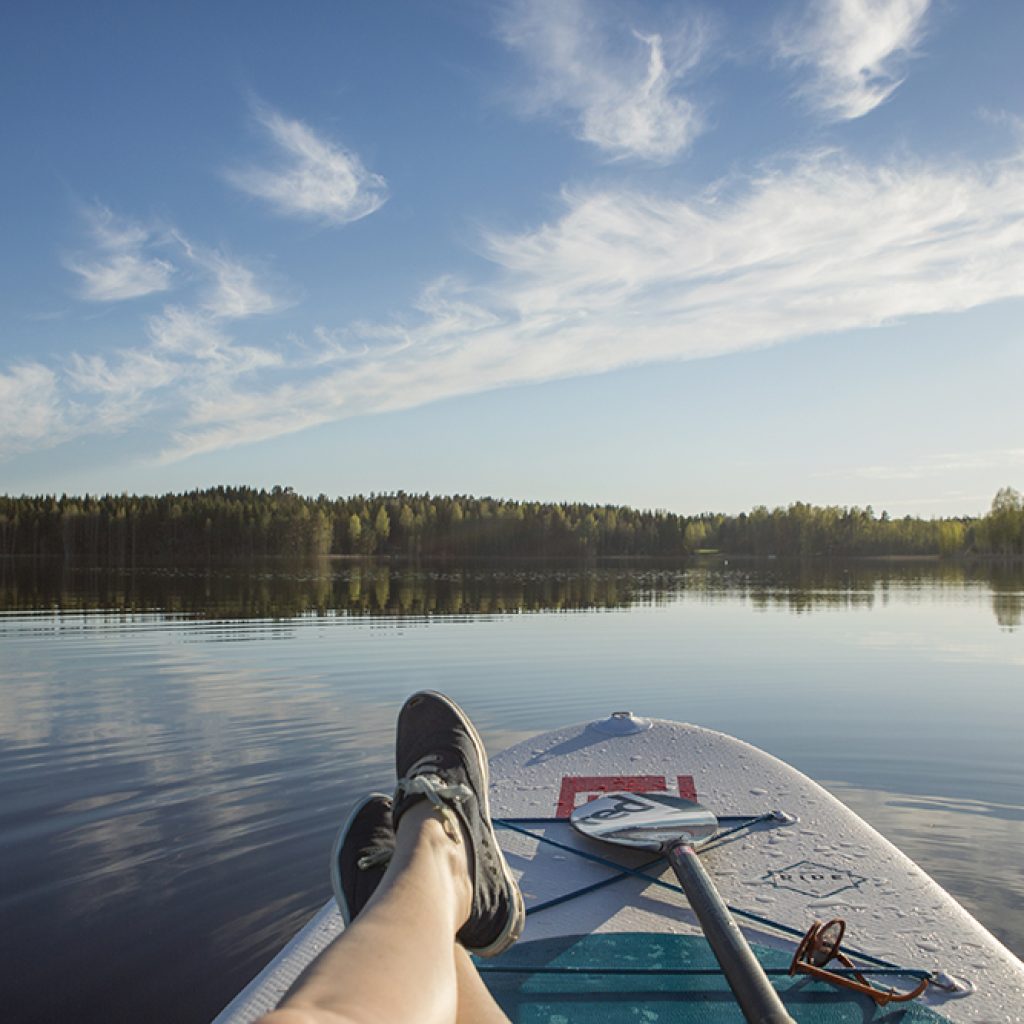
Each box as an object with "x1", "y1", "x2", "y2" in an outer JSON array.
[{"x1": 215, "y1": 713, "x2": 1024, "y2": 1024}]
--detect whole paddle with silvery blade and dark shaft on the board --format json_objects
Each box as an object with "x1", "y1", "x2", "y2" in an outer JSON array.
[{"x1": 569, "y1": 793, "x2": 796, "y2": 1024}]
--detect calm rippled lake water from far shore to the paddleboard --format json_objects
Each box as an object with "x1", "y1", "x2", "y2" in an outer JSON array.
[{"x1": 0, "y1": 560, "x2": 1024, "y2": 1022}]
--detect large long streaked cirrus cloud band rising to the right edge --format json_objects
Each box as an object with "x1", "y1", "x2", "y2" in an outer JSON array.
[{"x1": 159, "y1": 144, "x2": 1024, "y2": 459}]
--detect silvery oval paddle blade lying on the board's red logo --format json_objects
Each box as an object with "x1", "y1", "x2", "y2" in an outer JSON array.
[{"x1": 569, "y1": 793, "x2": 718, "y2": 850}]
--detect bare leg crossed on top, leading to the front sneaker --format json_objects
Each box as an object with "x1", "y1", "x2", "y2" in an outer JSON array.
[{"x1": 261, "y1": 801, "x2": 475, "y2": 1024}]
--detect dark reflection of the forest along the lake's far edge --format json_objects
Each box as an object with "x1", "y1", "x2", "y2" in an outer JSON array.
[{"x1": 0, "y1": 558, "x2": 1024, "y2": 629}]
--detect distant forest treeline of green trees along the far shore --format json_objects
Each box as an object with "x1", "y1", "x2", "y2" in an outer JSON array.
[{"x1": 0, "y1": 486, "x2": 1024, "y2": 566}]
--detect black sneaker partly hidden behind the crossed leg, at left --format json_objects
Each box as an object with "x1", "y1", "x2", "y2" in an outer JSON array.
[{"x1": 331, "y1": 793, "x2": 394, "y2": 925}]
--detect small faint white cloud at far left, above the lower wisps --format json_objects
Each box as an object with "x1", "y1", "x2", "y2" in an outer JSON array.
[{"x1": 66, "y1": 206, "x2": 174, "y2": 302}]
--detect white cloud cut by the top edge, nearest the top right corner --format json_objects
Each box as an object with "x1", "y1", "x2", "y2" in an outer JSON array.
[{"x1": 778, "y1": 0, "x2": 931, "y2": 120}]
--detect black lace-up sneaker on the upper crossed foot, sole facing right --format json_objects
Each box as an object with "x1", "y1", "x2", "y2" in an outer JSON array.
[{"x1": 393, "y1": 690, "x2": 526, "y2": 956}]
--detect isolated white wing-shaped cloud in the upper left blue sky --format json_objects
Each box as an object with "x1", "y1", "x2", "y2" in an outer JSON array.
[{"x1": 227, "y1": 108, "x2": 387, "y2": 224}]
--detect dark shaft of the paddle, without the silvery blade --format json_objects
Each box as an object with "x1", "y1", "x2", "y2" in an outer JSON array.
[{"x1": 666, "y1": 843, "x2": 796, "y2": 1024}]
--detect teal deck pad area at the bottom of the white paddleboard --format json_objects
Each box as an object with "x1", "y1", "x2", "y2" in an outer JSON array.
[{"x1": 477, "y1": 932, "x2": 947, "y2": 1024}]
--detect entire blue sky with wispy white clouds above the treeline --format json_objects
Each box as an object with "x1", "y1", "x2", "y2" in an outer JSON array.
[{"x1": 0, "y1": 0, "x2": 1024, "y2": 515}]
